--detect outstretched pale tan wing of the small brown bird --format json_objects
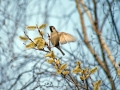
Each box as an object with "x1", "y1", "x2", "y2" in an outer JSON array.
[{"x1": 59, "y1": 32, "x2": 76, "y2": 44}]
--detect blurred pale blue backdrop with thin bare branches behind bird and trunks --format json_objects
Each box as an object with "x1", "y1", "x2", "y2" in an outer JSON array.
[{"x1": 0, "y1": 0, "x2": 120, "y2": 90}]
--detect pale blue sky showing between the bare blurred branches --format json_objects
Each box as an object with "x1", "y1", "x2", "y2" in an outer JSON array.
[{"x1": 0, "y1": 0, "x2": 120, "y2": 89}]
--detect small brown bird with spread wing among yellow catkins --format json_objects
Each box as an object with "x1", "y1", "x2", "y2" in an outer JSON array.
[{"x1": 49, "y1": 26, "x2": 76, "y2": 55}]
